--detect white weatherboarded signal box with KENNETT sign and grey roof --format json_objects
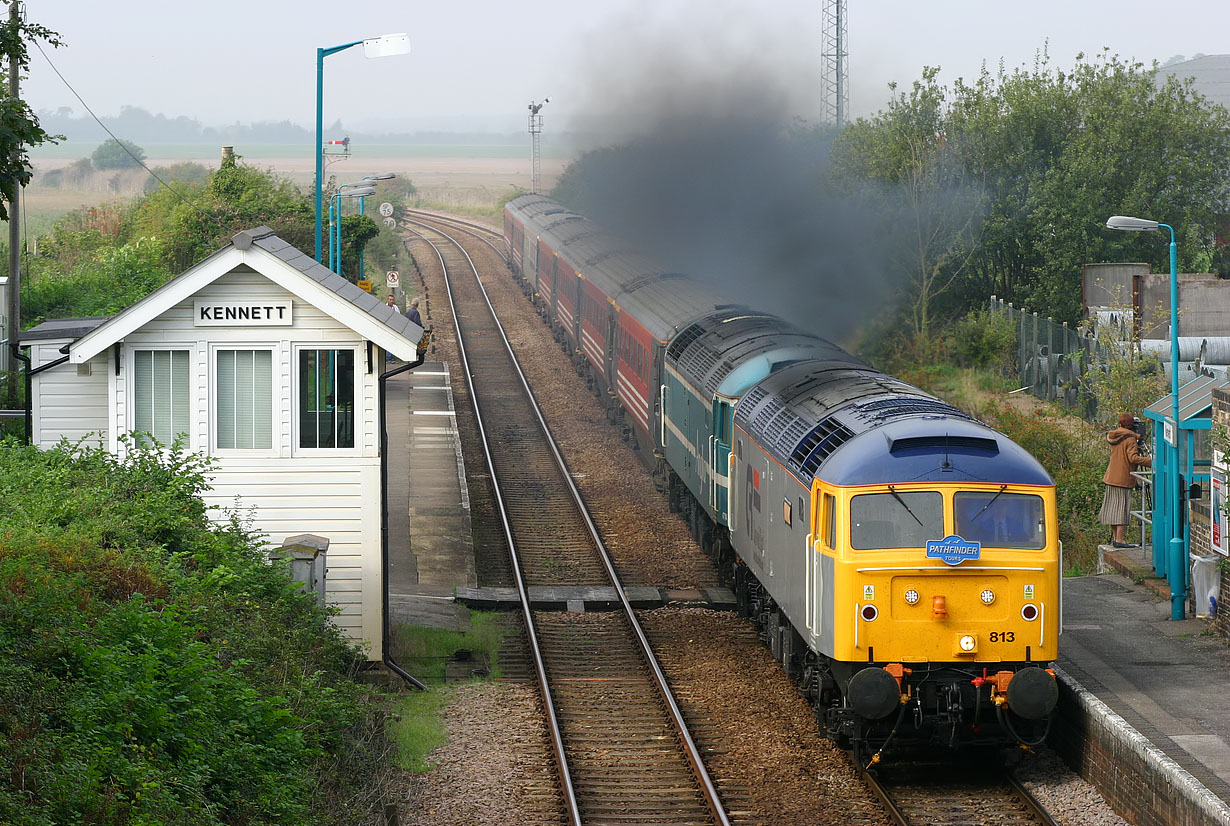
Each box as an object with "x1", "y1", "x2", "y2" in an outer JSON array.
[{"x1": 21, "y1": 226, "x2": 423, "y2": 660}]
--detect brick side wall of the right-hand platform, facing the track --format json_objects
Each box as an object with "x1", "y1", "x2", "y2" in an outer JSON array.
[{"x1": 1047, "y1": 669, "x2": 1230, "y2": 826}]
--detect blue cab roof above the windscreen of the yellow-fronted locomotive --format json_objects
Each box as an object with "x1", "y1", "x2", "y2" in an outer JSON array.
[{"x1": 817, "y1": 415, "x2": 1054, "y2": 486}]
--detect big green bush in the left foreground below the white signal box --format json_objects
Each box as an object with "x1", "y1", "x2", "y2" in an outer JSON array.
[{"x1": 0, "y1": 443, "x2": 383, "y2": 826}]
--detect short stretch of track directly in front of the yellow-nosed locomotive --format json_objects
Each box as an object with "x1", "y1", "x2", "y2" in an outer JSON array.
[{"x1": 863, "y1": 757, "x2": 1057, "y2": 826}]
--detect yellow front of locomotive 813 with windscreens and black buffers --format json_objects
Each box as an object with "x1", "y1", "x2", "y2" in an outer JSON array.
[{"x1": 813, "y1": 478, "x2": 1061, "y2": 762}]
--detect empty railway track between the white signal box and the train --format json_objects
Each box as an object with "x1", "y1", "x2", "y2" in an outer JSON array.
[{"x1": 406, "y1": 216, "x2": 731, "y2": 824}]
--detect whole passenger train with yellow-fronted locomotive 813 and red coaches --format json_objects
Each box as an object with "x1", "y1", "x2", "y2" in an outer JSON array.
[{"x1": 504, "y1": 195, "x2": 1061, "y2": 766}]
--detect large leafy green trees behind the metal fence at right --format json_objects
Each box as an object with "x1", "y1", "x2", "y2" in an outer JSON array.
[{"x1": 833, "y1": 50, "x2": 1230, "y2": 328}]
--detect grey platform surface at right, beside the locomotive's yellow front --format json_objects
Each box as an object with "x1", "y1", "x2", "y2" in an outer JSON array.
[{"x1": 1057, "y1": 546, "x2": 1230, "y2": 824}]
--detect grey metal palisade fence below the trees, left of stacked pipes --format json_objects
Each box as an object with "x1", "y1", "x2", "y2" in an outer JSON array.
[{"x1": 990, "y1": 296, "x2": 1108, "y2": 418}]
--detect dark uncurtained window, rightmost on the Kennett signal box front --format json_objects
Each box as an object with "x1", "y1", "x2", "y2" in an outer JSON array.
[{"x1": 299, "y1": 350, "x2": 354, "y2": 447}]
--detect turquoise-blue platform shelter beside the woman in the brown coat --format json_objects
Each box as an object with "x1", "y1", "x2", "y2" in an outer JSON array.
[{"x1": 1144, "y1": 375, "x2": 1230, "y2": 594}]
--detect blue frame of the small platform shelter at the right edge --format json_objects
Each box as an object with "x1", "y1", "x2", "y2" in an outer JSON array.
[{"x1": 1145, "y1": 376, "x2": 1230, "y2": 595}]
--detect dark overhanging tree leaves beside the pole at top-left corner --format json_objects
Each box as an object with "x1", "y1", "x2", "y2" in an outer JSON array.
[{"x1": 0, "y1": 10, "x2": 63, "y2": 221}]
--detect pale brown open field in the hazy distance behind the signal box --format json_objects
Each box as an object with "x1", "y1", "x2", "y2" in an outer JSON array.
[{"x1": 22, "y1": 141, "x2": 571, "y2": 226}]
